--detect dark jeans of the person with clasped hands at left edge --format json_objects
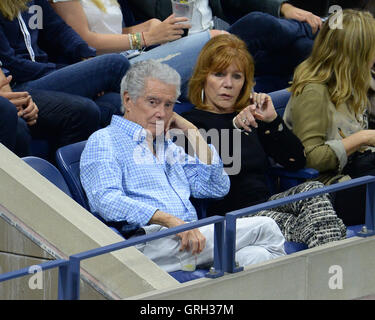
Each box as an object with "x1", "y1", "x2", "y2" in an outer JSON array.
[{"x1": 0, "y1": 90, "x2": 100, "y2": 161}]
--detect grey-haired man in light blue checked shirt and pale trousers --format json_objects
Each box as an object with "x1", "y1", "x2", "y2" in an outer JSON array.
[{"x1": 80, "y1": 60, "x2": 285, "y2": 272}]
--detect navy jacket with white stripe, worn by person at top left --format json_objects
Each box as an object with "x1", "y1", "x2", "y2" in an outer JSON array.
[{"x1": 0, "y1": 0, "x2": 96, "y2": 83}]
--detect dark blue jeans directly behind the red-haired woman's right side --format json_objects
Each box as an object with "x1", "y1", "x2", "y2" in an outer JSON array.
[{"x1": 228, "y1": 12, "x2": 316, "y2": 92}]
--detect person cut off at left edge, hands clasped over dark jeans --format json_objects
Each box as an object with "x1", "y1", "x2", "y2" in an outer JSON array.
[{"x1": 0, "y1": 70, "x2": 99, "y2": 162}]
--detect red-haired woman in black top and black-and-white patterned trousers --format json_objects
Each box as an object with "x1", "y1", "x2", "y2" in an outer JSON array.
[{"x1": 182, "y1": 35, "x2": 346, "y2": 248}]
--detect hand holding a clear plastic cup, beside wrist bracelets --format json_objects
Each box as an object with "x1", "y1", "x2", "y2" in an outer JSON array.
[{"x1": 144, "y1": 14, "x2": 191, "y2": 46}]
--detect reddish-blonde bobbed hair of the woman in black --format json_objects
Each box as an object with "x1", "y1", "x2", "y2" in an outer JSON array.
[{"x1": 189, "y1": 34, "x2": 254, "y2": 111}]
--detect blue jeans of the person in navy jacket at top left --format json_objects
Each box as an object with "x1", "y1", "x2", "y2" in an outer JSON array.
[{"x1": 13, "y1": 54, "x2": 130, "y2": 126}]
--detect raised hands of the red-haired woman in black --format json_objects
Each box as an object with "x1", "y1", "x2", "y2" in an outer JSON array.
[{"x1": 234, "y1": 92, "x2": 277, "y2": 132}]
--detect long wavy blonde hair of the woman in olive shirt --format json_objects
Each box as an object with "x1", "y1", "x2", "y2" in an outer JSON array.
[{"x1": 289, "y1": 9, "x2": 375, "y2": 113}]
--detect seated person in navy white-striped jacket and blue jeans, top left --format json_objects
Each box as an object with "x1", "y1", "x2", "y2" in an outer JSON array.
[{"x1": 0, "y1": 0, "x2": 129, "y2": 126}]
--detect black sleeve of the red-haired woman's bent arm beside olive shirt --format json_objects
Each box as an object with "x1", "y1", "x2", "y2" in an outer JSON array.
[{"x1": 258, "y1": 116, "x2": 306, "y2": 170}]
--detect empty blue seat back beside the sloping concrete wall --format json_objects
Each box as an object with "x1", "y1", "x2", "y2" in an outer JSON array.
[{"x1": 22, "y1": 156, "x2": 72, "y2": 197}]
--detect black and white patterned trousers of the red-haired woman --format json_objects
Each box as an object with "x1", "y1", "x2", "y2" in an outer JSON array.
[{"x1": 256, "y1": 181, "x2": 346, "y2": 248}]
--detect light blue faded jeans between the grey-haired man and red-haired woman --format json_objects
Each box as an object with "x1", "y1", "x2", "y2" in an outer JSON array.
[{"x1": 129, "y1": 31, "x2": 210, "y2": 101}]
